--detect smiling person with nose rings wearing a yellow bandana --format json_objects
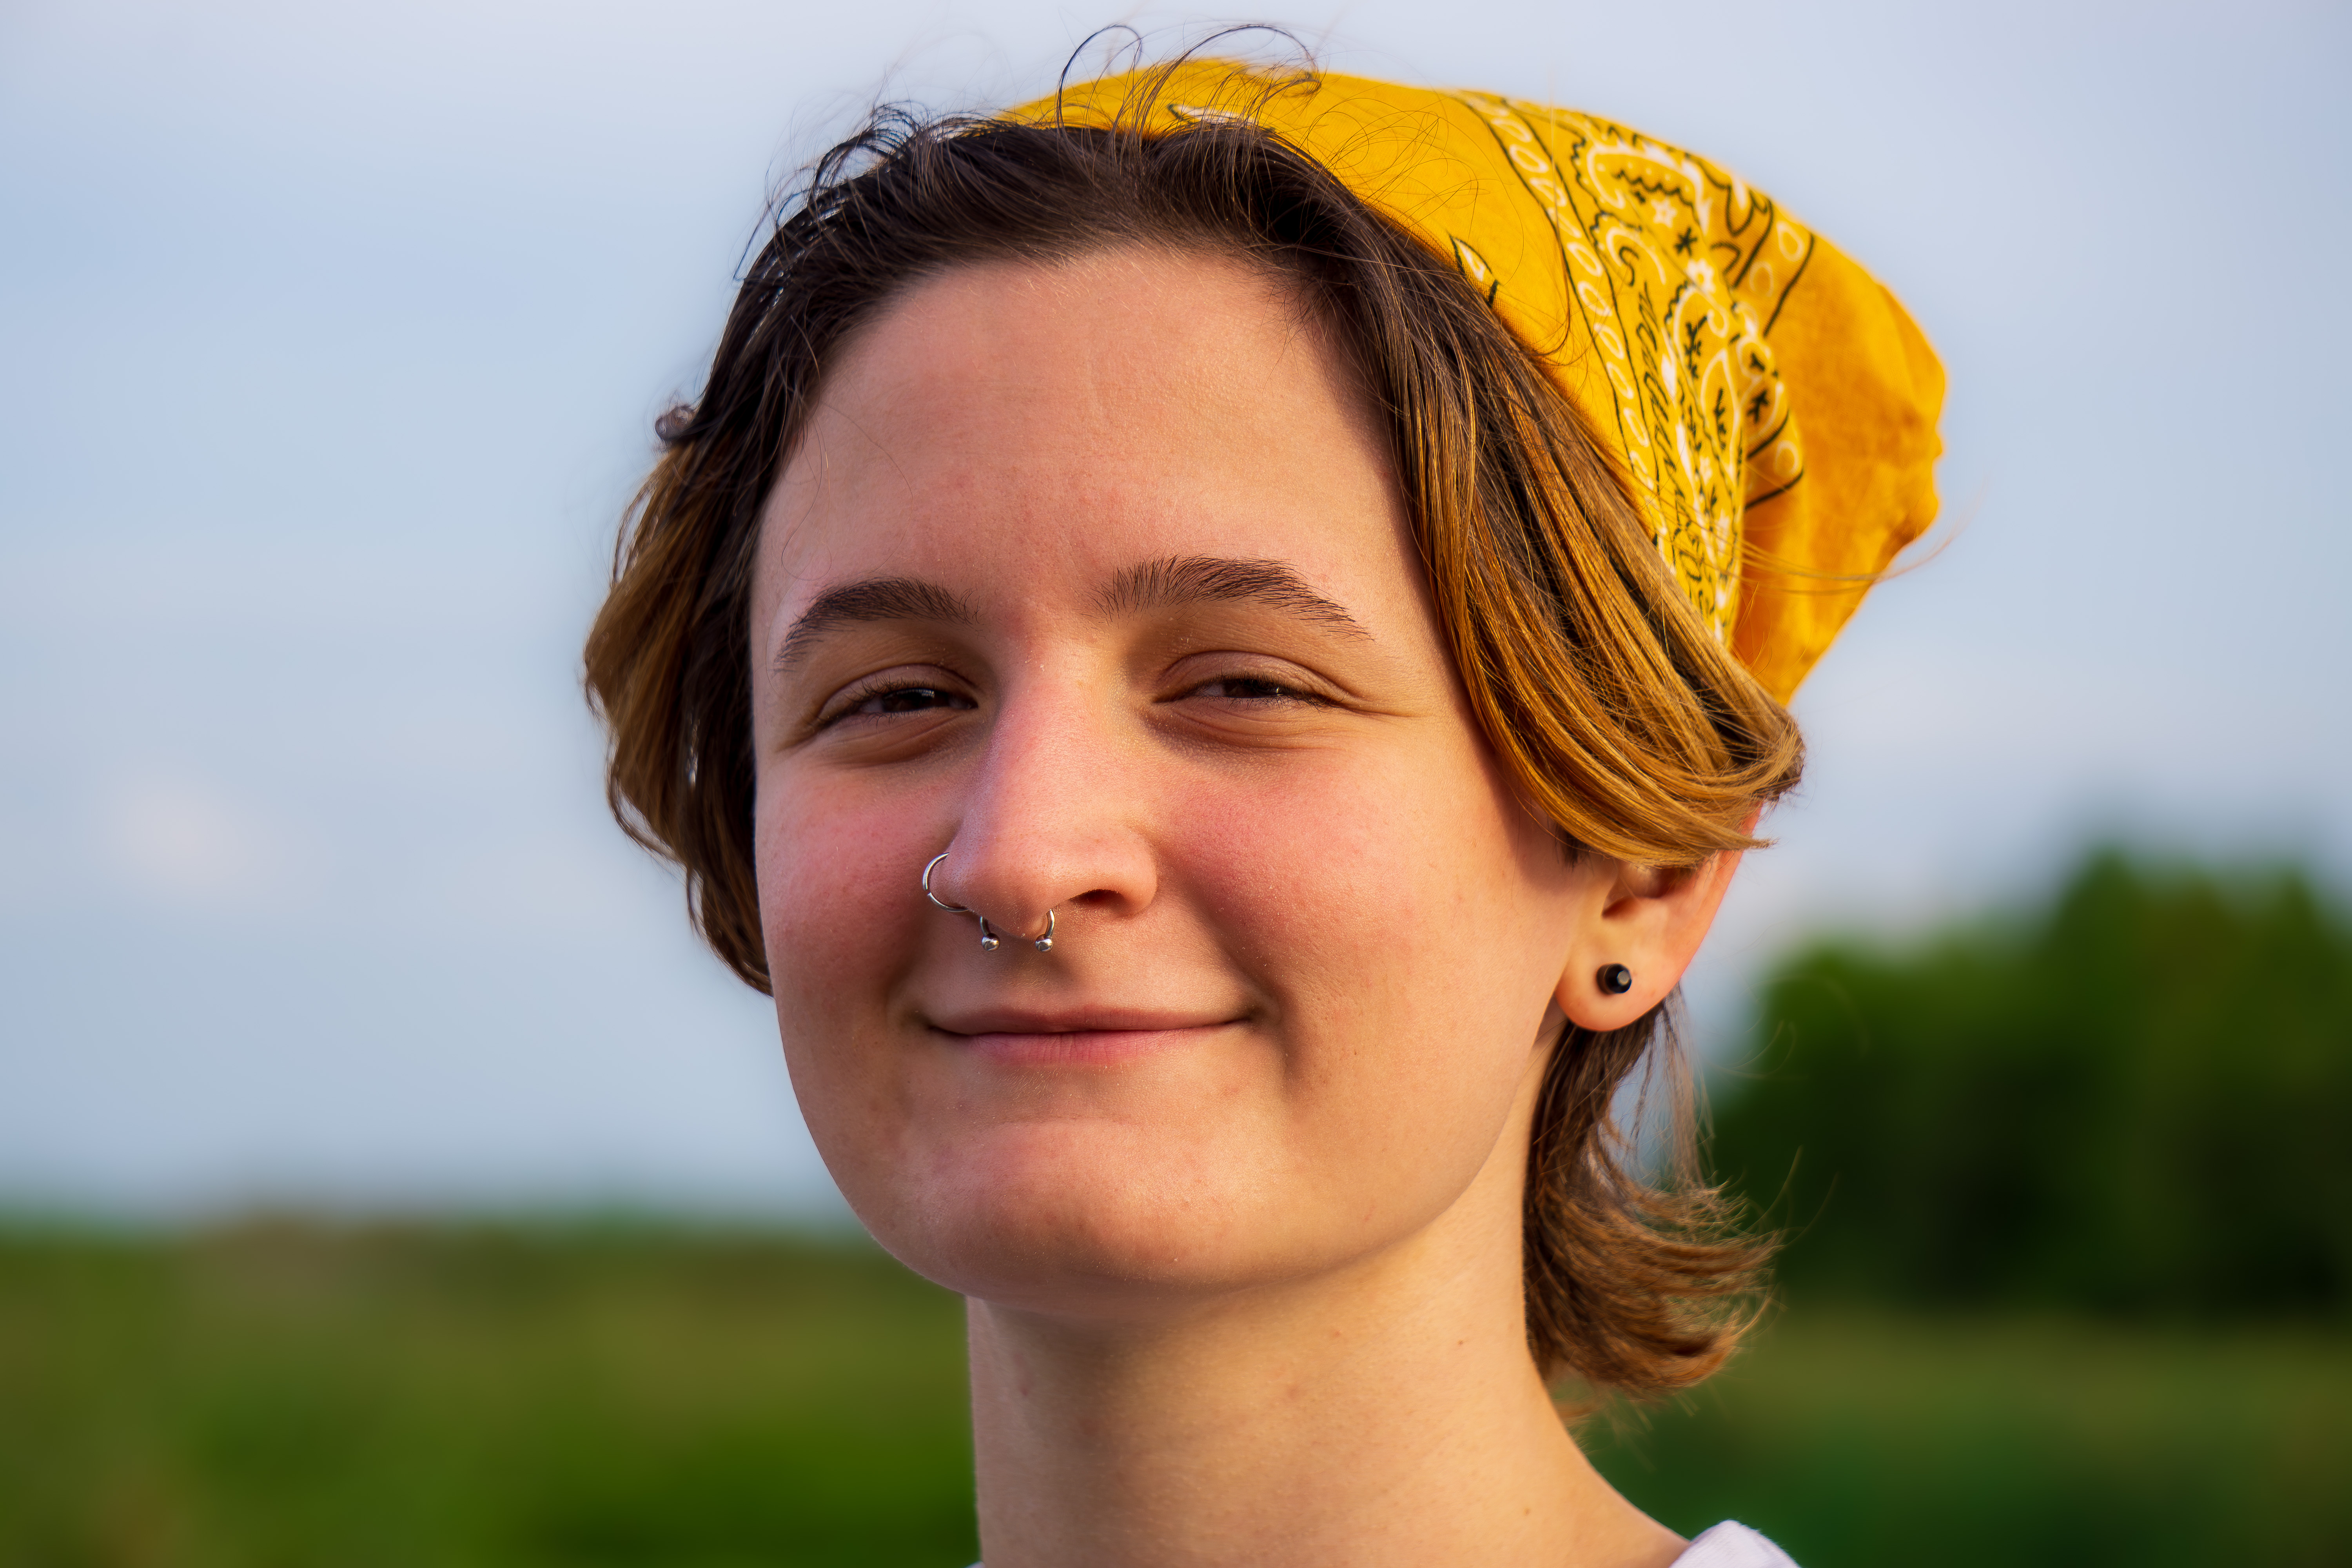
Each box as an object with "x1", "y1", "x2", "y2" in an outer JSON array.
[{"x1": 586, "y1": 59, "x2": 1940, "y2": 1568}]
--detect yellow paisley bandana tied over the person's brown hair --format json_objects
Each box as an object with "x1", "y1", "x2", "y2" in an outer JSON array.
[{"x1": 1009, "y1": 61, "x2": 1943, "y2": 703}]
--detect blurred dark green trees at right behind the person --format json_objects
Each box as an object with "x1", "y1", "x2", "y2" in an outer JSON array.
[{"x1": 1710, "y1": 849, "x2": 2352, "y2": 1319}]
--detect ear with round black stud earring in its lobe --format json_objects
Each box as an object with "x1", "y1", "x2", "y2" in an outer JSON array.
[{"x1": 1552, "y1": 811, "x2": 1762, "y2": 1030}]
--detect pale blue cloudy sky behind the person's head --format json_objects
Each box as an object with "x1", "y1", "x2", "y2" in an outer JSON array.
[{"x1": 0, "y1": 0, "x2": 2352, "y2": 1213}]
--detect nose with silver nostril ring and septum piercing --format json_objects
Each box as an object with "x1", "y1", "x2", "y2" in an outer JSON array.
[{"x1": 931, "y1": 677, "x2": 1160, "y2": 947}]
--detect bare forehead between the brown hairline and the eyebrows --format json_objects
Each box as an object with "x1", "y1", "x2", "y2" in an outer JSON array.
[{"x1": 757, "y1": 249, "x2": 1418, "y2": 621}]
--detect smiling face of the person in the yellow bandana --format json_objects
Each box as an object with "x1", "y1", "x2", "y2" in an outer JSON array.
[{"x1": 753, "y1": 249, "x2": 1595, "y2": 1312}]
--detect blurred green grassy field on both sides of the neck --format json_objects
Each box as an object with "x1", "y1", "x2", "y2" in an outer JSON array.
[{"x1": 0, "y1": 1225, "x2": 2352, "y2": 1568}]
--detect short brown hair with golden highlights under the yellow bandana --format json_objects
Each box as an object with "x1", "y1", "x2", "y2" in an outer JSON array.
[{"x1": 586, "y1": 73, "x2": 1802, "y2": 1394}]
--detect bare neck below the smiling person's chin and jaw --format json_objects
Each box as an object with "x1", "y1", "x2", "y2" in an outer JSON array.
[{"x1": 969, "y1": 1152, "x2": 1682, "y2": 1568}]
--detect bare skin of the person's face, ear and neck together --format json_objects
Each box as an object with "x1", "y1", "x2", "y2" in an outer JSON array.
[{"x1": 753, "y1": 249, "x2": 1733, "y2": 1568}]
